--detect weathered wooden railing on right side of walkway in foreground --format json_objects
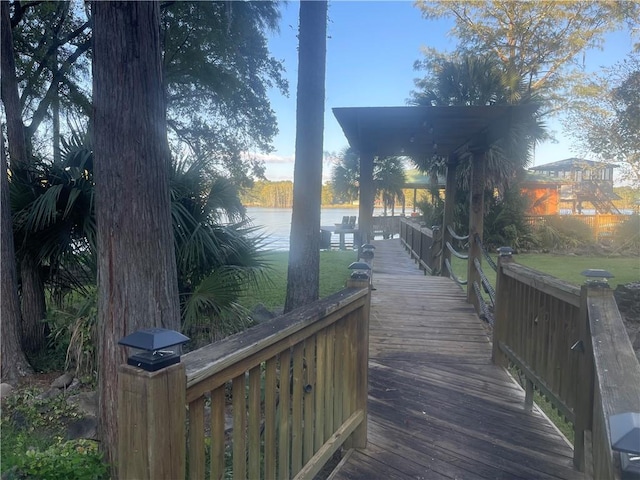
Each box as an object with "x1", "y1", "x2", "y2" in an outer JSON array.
[{"x1": 493, "y1": 255, "x2": 640, "y2": 479}]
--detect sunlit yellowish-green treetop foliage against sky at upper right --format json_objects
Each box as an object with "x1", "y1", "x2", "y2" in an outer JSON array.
[{"x1": 416, "y1": 0, "x2": 640, "y2": 109}]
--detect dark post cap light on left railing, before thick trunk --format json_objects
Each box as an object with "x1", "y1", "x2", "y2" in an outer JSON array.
[{"x1": 118, "y1": 328, "x2": 189, "y2": 372}]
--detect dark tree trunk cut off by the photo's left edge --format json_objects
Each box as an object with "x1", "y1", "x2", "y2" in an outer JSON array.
[{"x1": 0, "y1": 142, "x2": 32, "y2": 383}]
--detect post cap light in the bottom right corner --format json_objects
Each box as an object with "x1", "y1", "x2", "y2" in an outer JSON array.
[{"x1": 609, "y1": 412, "x2": 640, "y2": 478}]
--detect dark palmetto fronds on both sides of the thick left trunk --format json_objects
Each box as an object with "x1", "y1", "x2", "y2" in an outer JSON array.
[{"x1": 11, "y1": 133, "x2": 267, "y2": 352}]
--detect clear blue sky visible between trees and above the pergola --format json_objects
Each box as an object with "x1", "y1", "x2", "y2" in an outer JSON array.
[{"x1": 263, "y1": 0, "x2": 633, "y2": 181}]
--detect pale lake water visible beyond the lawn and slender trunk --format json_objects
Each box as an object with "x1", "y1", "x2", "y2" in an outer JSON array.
[{"x1": 247, "y1": 207, "x2": 382, "y2": 250}]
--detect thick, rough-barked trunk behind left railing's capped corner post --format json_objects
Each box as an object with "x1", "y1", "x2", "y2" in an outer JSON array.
[{"x1": 92, "y1": 1, "x2": 181, "y2": 470}]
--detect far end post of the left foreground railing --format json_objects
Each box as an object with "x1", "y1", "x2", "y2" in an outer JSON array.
[{"x1": 345, "y1": 279, "x2": 371, "y2": 448}]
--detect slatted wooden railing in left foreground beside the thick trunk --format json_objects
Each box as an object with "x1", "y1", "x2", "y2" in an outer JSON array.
[{"x1": 118, "y1": 280, "x2": 370, "y2": 480}]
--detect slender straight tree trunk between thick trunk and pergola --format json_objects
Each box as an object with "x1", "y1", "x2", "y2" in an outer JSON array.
[{"x1": 284, "y1": 0, "x2": 327, "y2": 312}]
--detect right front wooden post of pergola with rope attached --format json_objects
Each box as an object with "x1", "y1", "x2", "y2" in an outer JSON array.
[{"x1": 467, "y1": 149, "x2": 486, "y2": 312}]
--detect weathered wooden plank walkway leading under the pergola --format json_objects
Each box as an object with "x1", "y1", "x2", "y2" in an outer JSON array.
[{"x1": 330, "y1": 240, "x2": 583, "y2": 480}]
